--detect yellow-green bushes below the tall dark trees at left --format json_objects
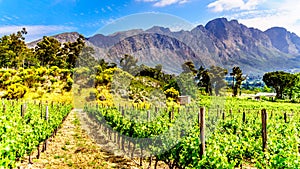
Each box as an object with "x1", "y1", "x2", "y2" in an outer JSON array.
[{"x1": 0, "y1": 66, "x2": 73, "y2": 99}]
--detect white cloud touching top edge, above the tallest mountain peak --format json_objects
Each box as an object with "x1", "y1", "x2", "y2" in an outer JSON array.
[{"x1": 207, "y1": 0, "x2": 265, "y2": 12}]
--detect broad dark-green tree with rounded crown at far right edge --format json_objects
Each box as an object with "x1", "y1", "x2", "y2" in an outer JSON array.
[{"x1": 263, "y1": 71, "x2": 297, "y2": 99}]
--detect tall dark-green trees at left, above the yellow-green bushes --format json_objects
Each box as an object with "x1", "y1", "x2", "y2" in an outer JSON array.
[{"x1": 0, "y1": 28, "x2": 85, "y2": 69}]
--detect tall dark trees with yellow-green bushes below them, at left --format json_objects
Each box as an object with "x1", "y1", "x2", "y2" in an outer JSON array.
[{"x1": 0, "y1": 28, "x2": 86, "y2": 99}]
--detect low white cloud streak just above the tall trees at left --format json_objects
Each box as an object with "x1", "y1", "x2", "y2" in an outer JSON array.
[{"x1": 0, "y1": 25, "x2": 76, "y2": 42}]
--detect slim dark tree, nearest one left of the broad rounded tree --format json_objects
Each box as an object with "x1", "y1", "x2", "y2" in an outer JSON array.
[{"x1": 230, "y1": 67, "x2": 246, "y2": 97}]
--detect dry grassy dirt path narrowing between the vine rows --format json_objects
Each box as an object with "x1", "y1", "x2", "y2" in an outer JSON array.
[{"x1": 19, "y1": 111, "x2": 139, "y2": 169}]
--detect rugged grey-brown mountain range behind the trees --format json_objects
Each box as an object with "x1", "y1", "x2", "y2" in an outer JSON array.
[{"x1": 28, "y1": 18, "x2": 300, "y2": 75}]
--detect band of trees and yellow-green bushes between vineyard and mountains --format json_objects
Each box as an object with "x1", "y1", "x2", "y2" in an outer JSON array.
[{"x1": 0, "y1": 28, "x2": 300, "y2": 102}]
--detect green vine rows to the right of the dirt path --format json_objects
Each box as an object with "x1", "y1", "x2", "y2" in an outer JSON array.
[{"x1": 85, "y1": 98, "x2": 300, "y2": 168}]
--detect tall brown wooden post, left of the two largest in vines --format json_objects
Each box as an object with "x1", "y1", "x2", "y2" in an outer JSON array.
[{"x1": 198, "y1": 107, "x2": 205, "y2": 159}]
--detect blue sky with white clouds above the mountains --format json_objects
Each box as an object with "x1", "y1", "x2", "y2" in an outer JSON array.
[{"x1": 0, "y1": 0, "x2": 300, "y2": 41}]
